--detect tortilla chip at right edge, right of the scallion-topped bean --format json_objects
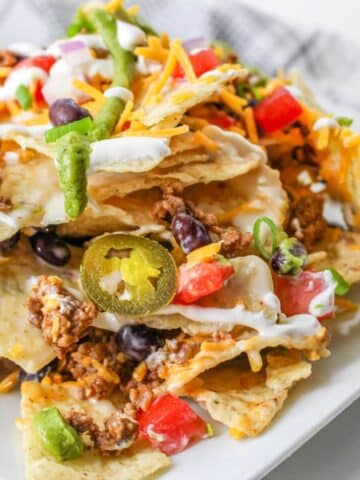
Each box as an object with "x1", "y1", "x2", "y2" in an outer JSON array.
[{"x1": 314, "y1": 232, "x2": 360, "y2": 285}]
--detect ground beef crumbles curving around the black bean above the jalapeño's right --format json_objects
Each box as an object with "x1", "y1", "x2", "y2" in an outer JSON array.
[{"x1": 153, "y1": 182, "x2": 252, "y2": 258}]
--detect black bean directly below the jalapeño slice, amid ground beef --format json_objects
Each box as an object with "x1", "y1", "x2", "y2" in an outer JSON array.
[{"x1": 116, "y1": 325, "x2": 164, "y2": 362}]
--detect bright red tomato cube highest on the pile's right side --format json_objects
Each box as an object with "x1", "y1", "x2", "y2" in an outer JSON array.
[{"x1": 254, "y1": 87, "x2": 303, "y2": 133}]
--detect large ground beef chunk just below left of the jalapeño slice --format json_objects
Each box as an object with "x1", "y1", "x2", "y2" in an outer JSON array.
[{"x1": 27, "y1": 275, "x2": 98, "y2": 359}]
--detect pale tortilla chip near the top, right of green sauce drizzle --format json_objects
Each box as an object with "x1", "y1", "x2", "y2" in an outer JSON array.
[{"x1": 138, "y1": 68, "x2": 248, "y2": 127}]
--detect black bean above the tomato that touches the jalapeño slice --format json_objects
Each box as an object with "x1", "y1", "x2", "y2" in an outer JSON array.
[{"x1": 171, "y1": 212, "x2": 211, "y2": 253}]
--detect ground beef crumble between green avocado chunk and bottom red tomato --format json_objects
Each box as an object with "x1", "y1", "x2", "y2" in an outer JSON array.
[{"x1": 65, "y1": 411, "x2": 139, "y2": 456}]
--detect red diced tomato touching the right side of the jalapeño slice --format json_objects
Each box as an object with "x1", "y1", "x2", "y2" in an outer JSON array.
[{"x1": 174, "y1": 262, "x2": 234, "y2": 304}]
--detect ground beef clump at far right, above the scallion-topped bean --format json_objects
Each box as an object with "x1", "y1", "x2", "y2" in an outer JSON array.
[{"x1": 289, "y1": 193, "x2": 327, "y2": 251}]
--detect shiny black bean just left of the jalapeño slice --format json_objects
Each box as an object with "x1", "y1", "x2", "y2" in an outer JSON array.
[{"x1": 30, "y1": 231, "x2": 71, "y2": 267}]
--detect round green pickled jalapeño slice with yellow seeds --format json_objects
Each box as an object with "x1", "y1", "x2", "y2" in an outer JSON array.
[{"x1": 81, "y1": 234, "x2": 177, "y2": 316}]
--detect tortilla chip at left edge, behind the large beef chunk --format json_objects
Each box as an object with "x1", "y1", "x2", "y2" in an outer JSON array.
[{"x1": 0, "y1": 239, "x2": 79, "y2": 373}]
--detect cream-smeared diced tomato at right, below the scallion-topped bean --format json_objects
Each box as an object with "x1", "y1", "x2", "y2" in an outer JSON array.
[{"x1": 275, "y1": 270, "x2": 336, "y2": 320}]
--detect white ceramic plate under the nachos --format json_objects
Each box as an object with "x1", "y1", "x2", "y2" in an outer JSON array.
[{"x1": 0, "y1": 290, "x2": 360, "y2": 480}]
